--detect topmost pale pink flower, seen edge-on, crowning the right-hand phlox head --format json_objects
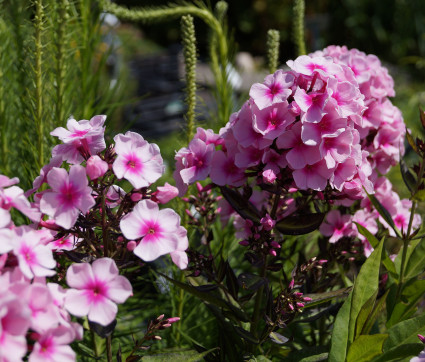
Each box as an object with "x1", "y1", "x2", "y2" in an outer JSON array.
[{"x1": 286, "y1": 55, "x2": 342, "y2": 79}]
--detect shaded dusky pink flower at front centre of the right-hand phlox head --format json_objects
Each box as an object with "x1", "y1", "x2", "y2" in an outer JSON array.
[{"x1": 276, "y1": 122, "x2": 321, "y2": 170}]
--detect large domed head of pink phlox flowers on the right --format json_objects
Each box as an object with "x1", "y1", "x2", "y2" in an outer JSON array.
[{"x1": 174, "y1": 46, "x2": 410, "y2": 255}]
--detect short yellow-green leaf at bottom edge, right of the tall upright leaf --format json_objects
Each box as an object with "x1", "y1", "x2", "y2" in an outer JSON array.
[{"x1": 347, "y1": 334, "x2": 388, "y2": 362}]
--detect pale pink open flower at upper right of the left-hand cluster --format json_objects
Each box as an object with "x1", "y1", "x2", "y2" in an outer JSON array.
[{"x1": 112, "y1": 131, "x2": 164, "y2": 189}]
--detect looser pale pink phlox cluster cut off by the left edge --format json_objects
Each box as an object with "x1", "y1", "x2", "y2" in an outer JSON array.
[{"x1": 0, "y1": 116, "x2": 188, "y2": 362}]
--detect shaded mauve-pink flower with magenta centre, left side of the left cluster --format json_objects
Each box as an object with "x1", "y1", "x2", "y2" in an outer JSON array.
[{"x1": 40, "y1": 165, "x2": 95, "y2": 229}]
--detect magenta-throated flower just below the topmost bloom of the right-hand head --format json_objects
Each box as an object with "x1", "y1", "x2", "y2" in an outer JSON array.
[{"x1": 294, "y1": 87, "x2": 329, "y2": 123}]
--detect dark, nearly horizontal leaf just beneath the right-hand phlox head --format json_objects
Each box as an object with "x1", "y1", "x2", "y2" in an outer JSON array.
[{"x1": 276, "y1": 213, "x2": 326, "y2": 235}]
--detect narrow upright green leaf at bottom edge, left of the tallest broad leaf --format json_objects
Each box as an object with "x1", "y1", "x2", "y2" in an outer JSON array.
[{"x1": 329, "y1": 293, "x2": 353, "y2": 362}]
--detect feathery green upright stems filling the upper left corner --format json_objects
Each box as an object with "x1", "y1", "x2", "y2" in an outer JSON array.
[{"x1": 0, "y1": 0, "x2": 126, "y2": 188}]
